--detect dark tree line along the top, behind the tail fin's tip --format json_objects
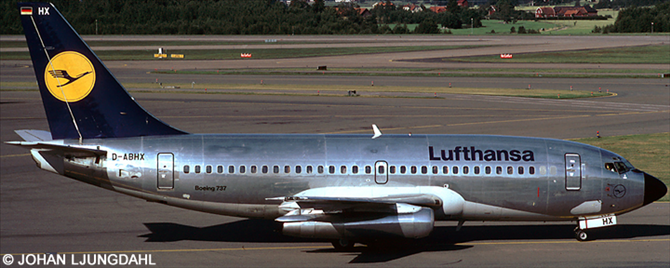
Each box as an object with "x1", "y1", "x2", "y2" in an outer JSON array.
[{"x1": 0, "y1": 0, "x2": 481, "y2": 35}]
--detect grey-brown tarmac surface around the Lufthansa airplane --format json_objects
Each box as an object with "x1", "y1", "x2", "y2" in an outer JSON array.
[{"x1": 0, "y1": 34, "x2": 670, "y2": 267}]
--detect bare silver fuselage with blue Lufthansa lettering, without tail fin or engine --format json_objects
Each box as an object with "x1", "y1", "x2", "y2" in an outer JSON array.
[{"x1": 40, "y1": 134, "x2": 644, "y2": 220}]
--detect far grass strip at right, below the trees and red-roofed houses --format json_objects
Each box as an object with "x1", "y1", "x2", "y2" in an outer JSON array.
[{"x1": 444, "y1": 44, "x2": 670, "y2": 64}]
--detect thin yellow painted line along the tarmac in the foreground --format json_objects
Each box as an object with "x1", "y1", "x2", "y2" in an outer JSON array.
[{"x1": 0, "y1": 238, "x2": 670, "y2": 256}]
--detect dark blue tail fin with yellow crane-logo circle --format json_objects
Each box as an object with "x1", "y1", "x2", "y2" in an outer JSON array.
[{"x1": 18, "y1": 3, "x2": 186, "y2": 140}]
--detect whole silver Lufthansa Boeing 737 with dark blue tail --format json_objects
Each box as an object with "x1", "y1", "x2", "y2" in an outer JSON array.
[{"x1": 8, "y1": 3, "x2": 667, "y2": 250}]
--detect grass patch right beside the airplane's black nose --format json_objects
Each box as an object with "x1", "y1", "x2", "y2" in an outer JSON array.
[{"x1": 574, "y1": 132, "x2": 670, "y2": 201}]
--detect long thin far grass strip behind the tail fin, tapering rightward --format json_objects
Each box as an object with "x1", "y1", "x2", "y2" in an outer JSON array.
[{"x1": 0, "y1": 46, "x2": 483, "y2": 60}]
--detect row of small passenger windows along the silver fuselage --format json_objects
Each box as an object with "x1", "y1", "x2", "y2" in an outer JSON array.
[{"x1": 184, "y1": 165, "x2": 535, "y2": 175}]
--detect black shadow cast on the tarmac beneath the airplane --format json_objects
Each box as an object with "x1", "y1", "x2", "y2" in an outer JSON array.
[{"x1": 140, "y1": 219, "x2": 670, "y2": 263}]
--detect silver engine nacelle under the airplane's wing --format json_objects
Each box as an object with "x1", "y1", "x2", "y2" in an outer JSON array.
[{"x1": 282, "y1": 208, "x2": 435, "y2": 239}]
